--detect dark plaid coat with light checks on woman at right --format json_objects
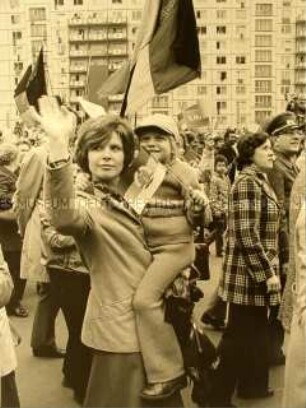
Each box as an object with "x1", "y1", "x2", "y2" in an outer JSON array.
[{"x1": 220, "y1": 165, "x2": 280, "y2": 306}]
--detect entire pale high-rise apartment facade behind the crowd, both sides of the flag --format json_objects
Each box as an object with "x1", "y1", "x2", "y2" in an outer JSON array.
[{"x1": 0, "y1": 0, "x2": 306, "y2": 130}]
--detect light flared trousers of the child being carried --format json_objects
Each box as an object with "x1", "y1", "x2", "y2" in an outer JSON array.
[{"x1": 134, "y1": 240, "x2": 195, "y2": 383}]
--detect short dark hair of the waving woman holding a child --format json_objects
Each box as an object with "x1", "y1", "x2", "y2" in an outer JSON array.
[{"x1": 75, "y1": 115, "x2": 137, "y2": 173}]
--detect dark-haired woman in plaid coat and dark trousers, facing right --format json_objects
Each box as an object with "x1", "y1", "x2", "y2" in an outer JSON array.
[{"x1": 211, "y1": 133, "x2": 280, "y2": 407}]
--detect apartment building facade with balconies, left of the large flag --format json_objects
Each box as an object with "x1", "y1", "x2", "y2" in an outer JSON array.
[{"x1": 0, "y1": 0, "x2": 144, "y2": 128}]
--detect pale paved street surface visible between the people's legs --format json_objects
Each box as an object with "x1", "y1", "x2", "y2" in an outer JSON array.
[{"x1": 13, "y1": 256, "x2": 283, "y2": 408}]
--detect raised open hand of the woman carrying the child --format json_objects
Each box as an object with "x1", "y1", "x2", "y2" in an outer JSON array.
[{"x1": 33, "y1": 96, "x2": 76, "y2": 161}]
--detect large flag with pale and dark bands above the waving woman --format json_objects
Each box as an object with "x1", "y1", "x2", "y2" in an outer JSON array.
[{"x1": 122, "y1": 0, "x2": 201, "y2": 113}]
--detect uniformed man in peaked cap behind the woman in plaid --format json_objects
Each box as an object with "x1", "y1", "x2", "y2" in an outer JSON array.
[{"x1": 264, "y1": 112, "x2": 301, "y2": 365}]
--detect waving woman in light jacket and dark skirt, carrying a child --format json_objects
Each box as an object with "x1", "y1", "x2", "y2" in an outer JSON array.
[{"x1": 32, "y1": 97, "x2": 207, "y2": 407}]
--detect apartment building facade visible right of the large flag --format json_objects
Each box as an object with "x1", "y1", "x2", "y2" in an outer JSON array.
[{"x1": 167, "y1": 0, "x2": 306, "y2": 129}]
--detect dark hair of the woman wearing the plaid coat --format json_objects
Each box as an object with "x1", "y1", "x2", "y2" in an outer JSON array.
[{"x1": 236, "y1": 132, "x2": 269, "y2": 170}]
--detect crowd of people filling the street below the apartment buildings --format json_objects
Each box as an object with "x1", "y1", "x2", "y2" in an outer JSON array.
[{"x1": 0, "y1": 96, "x2": 306, "y2": 408}]
